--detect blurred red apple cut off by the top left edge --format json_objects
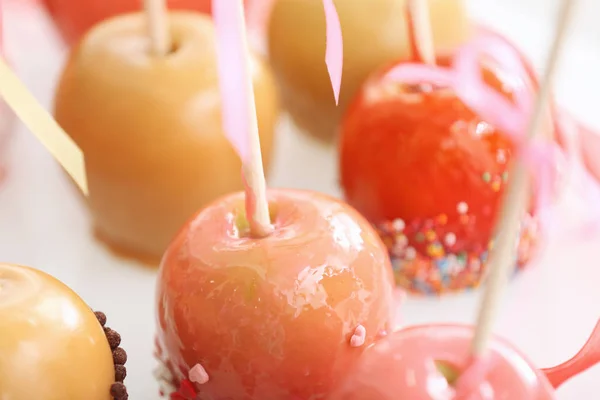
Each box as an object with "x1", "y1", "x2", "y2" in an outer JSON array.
[{"x1": 43, "y1": 0, "x2": 246, "y2": 44}]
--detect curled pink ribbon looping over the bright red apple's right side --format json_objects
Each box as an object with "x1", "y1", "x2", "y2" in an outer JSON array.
[{"x1": 385, "y1": 34, "x2": 600, "y2": 236}]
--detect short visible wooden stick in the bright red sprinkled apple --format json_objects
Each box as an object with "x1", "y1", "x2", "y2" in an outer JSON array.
[{"x1": 407, "y1": 0, "x2": 436, "y2": 65}]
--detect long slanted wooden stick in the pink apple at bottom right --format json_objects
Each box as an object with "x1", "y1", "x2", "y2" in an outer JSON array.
[{"x1": 471, "y1": 0, "x2": 575, "y2": 357}]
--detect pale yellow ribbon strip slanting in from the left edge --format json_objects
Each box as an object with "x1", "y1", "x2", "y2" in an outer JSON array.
[{"x1": 0, "y1": 57, "x2": 88, "y2": 195}]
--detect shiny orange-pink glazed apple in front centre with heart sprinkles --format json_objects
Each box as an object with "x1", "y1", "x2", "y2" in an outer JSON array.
[{"x1": 157, "y1": 190, "x2": 394, "y2": 400}]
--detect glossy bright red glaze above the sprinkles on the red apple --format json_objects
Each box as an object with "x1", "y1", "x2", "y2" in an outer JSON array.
[{"x1": 340, "y1": 54, "x2": 514, "y2": 252}]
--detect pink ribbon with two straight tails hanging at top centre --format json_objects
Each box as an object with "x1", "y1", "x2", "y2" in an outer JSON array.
[{"x1": 212, "y1": 0, "x2": 343, "y2": 163}]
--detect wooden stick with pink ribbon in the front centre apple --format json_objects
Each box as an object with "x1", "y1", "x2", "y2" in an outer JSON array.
[{"x1": 212, "y1": 0, "x2": 273, "y2": 237}]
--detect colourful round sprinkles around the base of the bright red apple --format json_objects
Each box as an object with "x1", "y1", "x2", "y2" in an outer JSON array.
[{"x1": 375, "y1": 214, "x2": 539, "y2": 295}]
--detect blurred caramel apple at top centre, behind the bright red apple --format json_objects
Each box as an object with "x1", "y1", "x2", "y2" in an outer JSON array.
[{"x1": 268, "y1": 0, "x2": 470, "y2": 140}]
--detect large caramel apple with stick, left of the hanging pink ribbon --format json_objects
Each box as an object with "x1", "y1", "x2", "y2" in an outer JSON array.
[{"x1": 55, "y1": 12, "x2": 278, "y2": 263}]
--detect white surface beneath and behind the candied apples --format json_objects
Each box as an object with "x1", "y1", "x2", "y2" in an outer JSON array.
[{"x1": 0, "y1": 0, "x2": 600, "y2": 400}]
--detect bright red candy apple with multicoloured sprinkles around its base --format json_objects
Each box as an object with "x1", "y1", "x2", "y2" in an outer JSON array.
[{"x1": 340, "y1": 54, "x2": 536, "y2": 293}]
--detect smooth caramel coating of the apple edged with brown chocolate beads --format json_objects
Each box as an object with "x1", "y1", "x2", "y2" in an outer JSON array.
[{"x1": 0, "y1": 264, "x2": 115, "y2": 400}]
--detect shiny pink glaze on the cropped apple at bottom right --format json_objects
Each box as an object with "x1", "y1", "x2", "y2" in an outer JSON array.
[{"x1": 328, "y1": 325, "x2": 555, "y2": 400}]
